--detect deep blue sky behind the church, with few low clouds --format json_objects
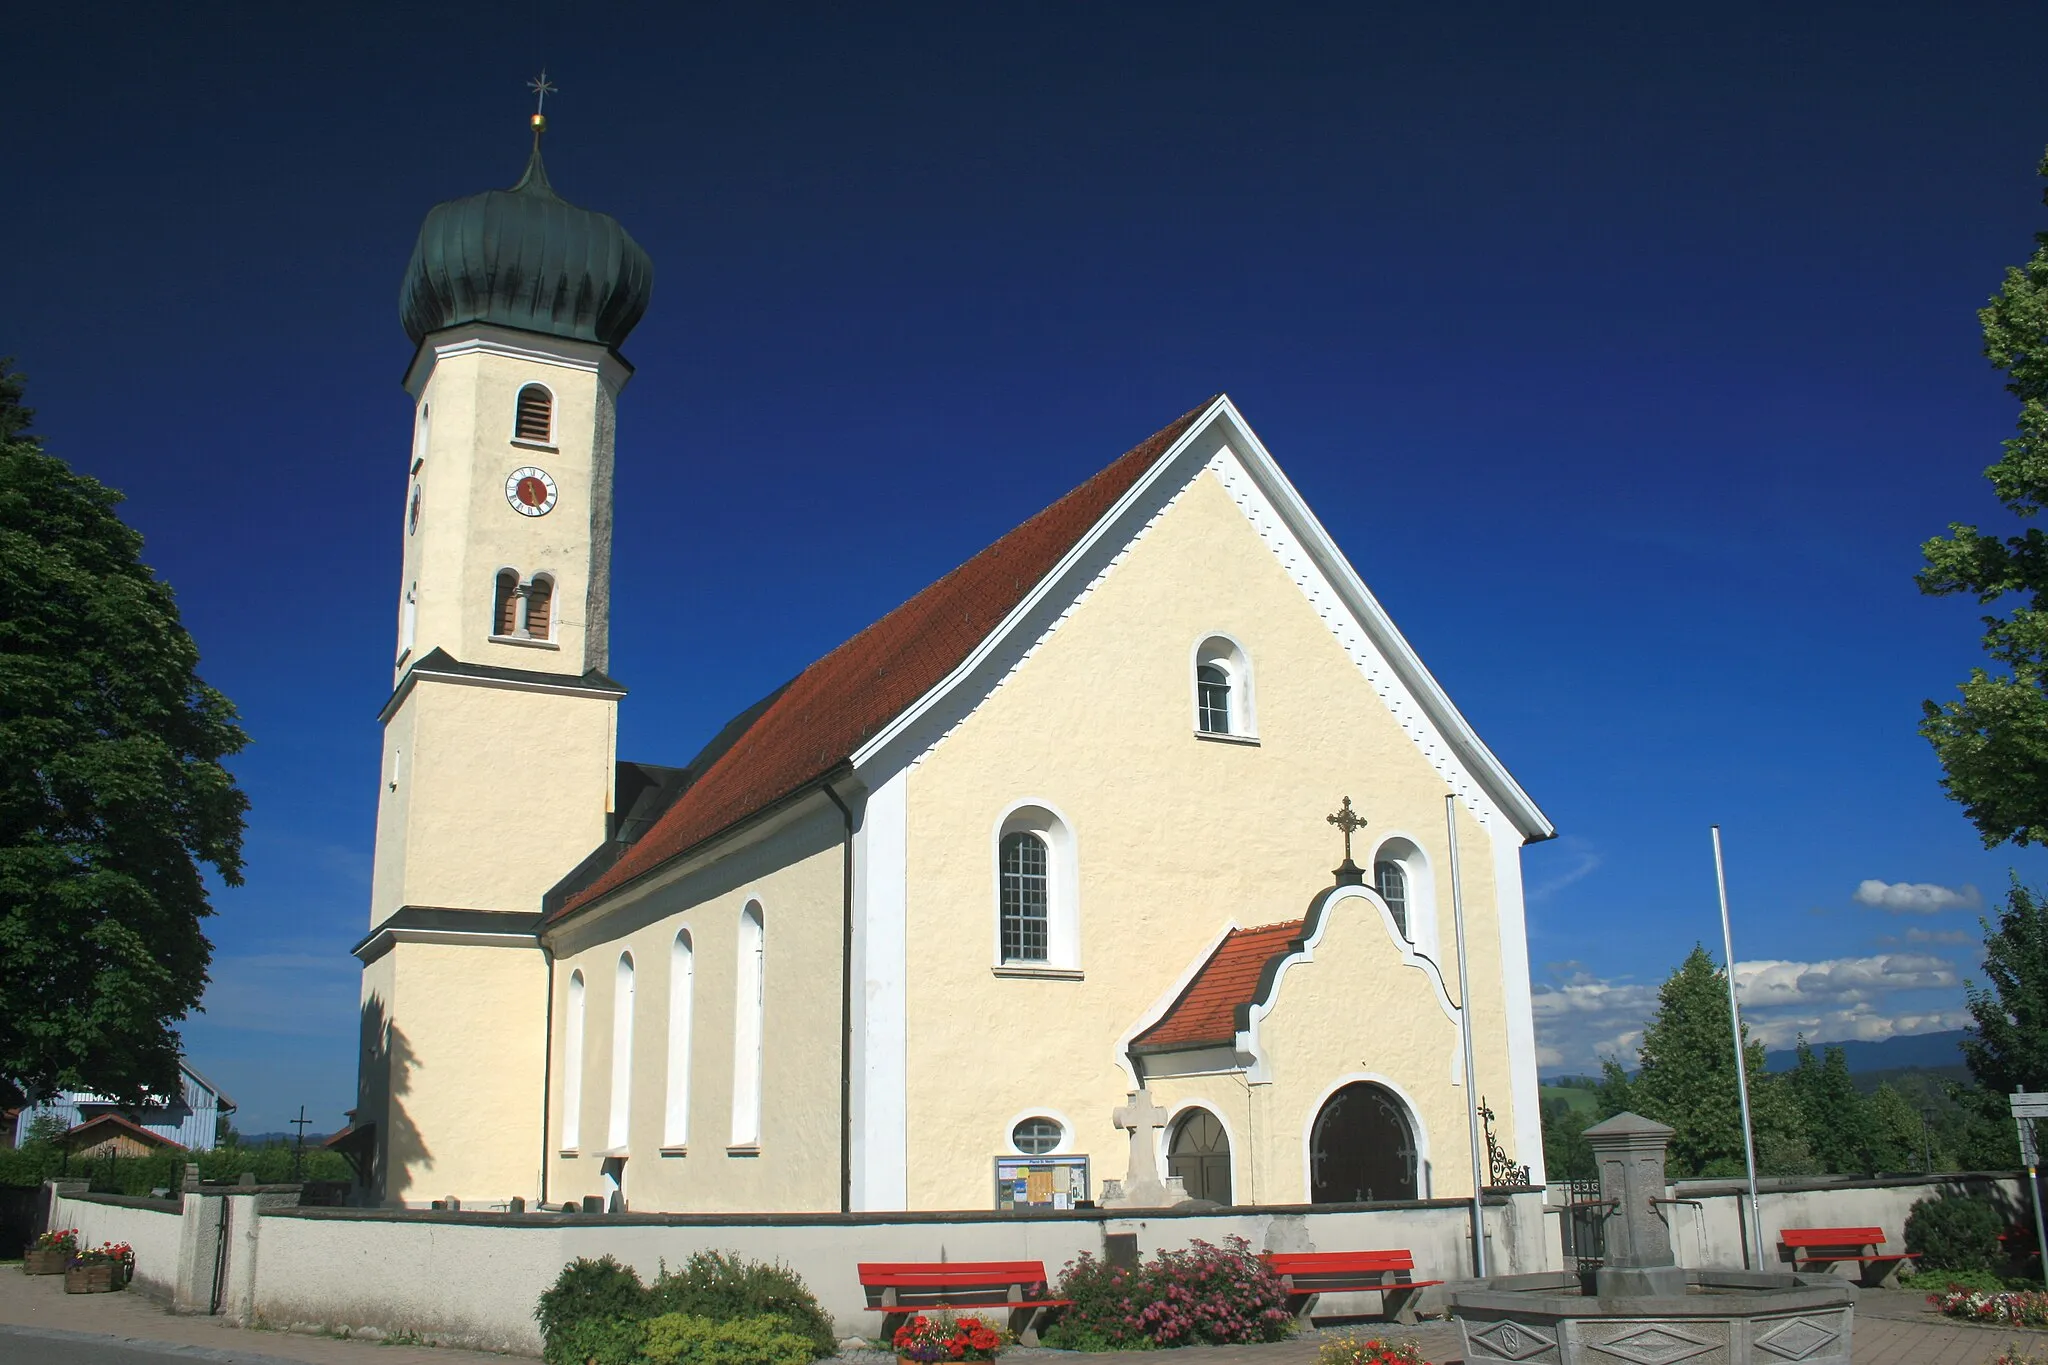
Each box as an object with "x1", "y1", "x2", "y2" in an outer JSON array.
[{"x1": 12, "y1": 4, "x2": 2048, "y2": 1130}]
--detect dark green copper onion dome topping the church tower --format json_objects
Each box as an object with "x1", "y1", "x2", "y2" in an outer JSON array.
[{"x1": 397, "y1": 137, "x2": 653, "y2": 350}]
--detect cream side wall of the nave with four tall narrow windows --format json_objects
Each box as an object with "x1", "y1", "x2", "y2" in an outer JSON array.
[{"x1": 549, "y1": 798, "x2": 844, "y2": 1212}]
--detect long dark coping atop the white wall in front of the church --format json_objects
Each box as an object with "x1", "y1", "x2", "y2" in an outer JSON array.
[{"x1": 258, "y1": 1185, "x2": 1542, "y2": 1228}]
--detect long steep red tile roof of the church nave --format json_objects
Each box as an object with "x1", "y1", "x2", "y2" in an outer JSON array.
[{"x1": 549, "y1": 399, "x2": 1214, "y2": 921}]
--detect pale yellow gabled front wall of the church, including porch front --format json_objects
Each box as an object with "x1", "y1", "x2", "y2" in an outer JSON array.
[{"x1": 907, "y1": 473, "x2": 1516, "y2": 1207}]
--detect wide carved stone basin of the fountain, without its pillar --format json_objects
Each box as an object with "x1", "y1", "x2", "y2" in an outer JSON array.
[{"x1": 1450, "y1": 1269, "x2": 1855, "y2": 1365}]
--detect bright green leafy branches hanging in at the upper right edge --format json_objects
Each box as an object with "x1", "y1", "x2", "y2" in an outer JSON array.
[{"x1": 1915, "y1": 144, "x2": 2048, "y2": 847}]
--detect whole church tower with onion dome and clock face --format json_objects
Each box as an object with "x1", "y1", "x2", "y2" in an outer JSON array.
[{"x1": 352, "y1": 115, "x2": 653, "y2": 1207}]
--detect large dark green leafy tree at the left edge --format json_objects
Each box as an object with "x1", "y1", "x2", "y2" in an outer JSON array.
[{"x1": 0, "y1": 362, "x2": 248, "y2": 1101}]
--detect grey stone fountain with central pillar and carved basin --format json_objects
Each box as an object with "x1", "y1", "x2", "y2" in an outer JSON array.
[{"x1": 1450, "y1": 1113, "x2": 1855, "y2": 1365}]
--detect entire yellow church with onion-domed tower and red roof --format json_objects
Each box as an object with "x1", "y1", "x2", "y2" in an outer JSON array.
[{"x1": 348, "y1": 119, "x2": 1554, "y2": 1212}]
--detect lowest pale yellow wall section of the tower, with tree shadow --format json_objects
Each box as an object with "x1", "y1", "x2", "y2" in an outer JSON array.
[{"x1": 358, "y1": 941, "x2": 547, "y2": 1207}]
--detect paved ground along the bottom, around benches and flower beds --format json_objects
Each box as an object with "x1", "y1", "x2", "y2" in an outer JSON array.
[{"x1": 0, "y1": 1265, "x2": 2048, "y2": 1365}]
